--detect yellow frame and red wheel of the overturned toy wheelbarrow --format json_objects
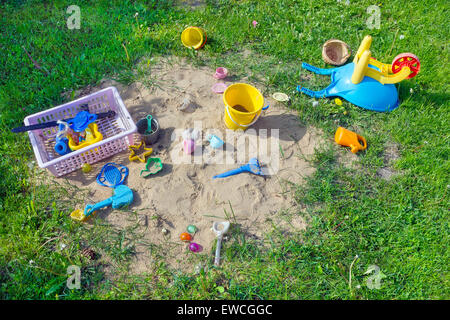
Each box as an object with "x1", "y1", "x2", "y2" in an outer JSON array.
[{"x1": 351, "y1": 36, "x2": 420, "y2": 84}]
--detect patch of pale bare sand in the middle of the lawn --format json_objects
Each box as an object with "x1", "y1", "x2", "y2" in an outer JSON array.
[{"x1": 66, "y1": 59, "x2": 320, "y2": 273}]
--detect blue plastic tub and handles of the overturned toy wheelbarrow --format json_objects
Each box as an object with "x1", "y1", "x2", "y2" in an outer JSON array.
[{"x1": 297, "y1": 62, "x2": 399, "y2": 112}]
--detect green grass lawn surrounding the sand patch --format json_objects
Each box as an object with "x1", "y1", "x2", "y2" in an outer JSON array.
[{"x1": 0, "y1": 0, "x2": 450, "y2": 299}]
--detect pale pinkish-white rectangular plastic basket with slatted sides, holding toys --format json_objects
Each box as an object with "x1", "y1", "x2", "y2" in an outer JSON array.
[{"x1": 24, "y1": 87, "x2": 137, "y2": 177}]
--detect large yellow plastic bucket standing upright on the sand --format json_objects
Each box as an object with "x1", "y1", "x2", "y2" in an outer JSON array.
[{"x1": 223, "y1": 83, "x2": 268, "y2": 130}]
